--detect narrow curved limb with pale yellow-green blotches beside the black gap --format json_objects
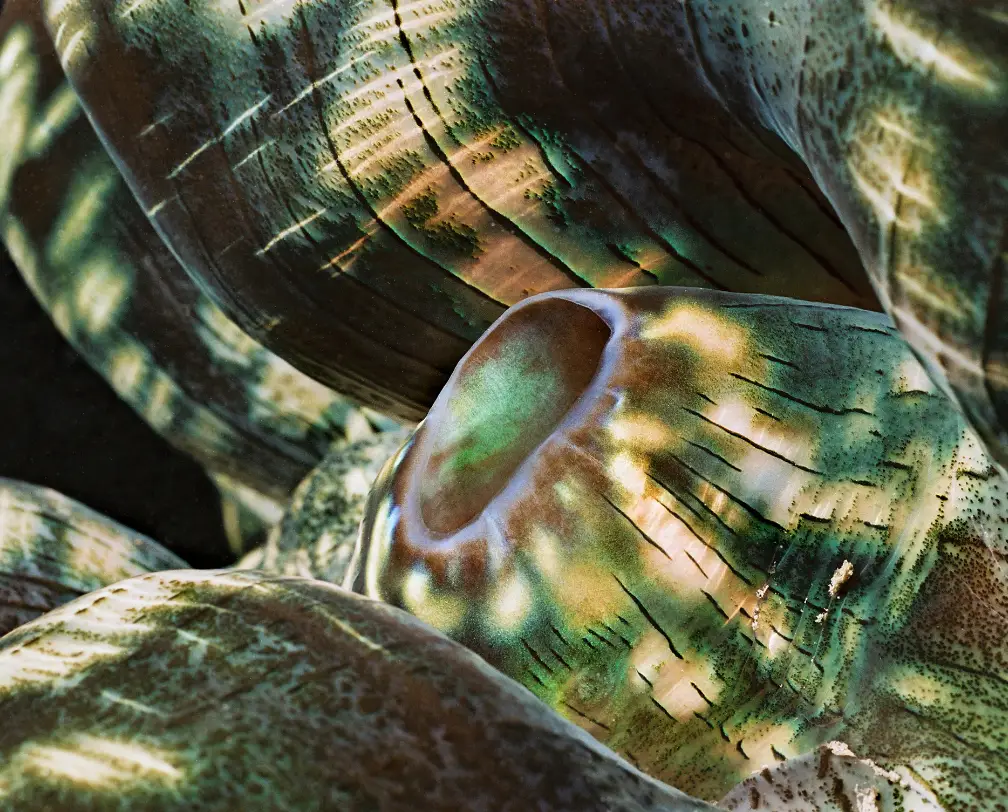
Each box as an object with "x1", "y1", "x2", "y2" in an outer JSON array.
[{"x1": 0, "y1": 0, "x2": 387, "y2": 501}]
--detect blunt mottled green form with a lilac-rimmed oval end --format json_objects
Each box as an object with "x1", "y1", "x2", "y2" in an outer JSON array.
[{"x1": 358, "y1": 289, "x2": 1008, "y2": 809}]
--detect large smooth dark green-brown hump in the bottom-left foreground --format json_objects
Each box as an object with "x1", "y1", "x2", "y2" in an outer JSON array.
[{"x1": 0, "y1": 571, "x2": 710, "y2": 812}]
